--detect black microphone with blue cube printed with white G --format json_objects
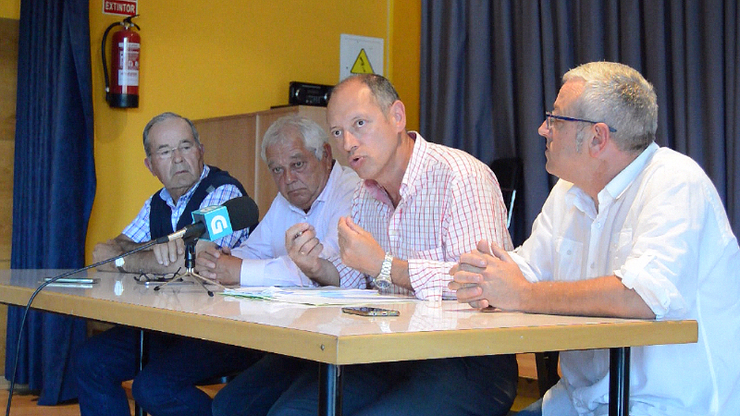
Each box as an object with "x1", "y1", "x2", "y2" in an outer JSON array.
[{"x1": 156, "y1": 195, "x2": 259, "y2": 244}]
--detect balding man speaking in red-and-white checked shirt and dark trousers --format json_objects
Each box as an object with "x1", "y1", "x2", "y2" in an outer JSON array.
[{"x1": 270, "y1": 74, "x2": 518, "y2": 416}]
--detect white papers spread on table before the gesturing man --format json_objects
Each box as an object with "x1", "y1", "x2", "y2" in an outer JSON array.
[{"x1": 222, "y1": 287, "x2": 416, "y2": 306}]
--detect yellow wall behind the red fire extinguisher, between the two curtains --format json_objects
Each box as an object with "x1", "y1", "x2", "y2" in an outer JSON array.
[{"x1": 87, "y1": 0, "x2": 421, "y2": 260}]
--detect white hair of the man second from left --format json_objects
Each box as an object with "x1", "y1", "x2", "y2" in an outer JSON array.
[{"x1": 260, "y1": 114, "x2": 329, "y2": 163}]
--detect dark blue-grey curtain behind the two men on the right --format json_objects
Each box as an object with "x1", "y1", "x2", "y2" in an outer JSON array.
[{"x1": 420, "y1": 0, "x2": 740, "y2": 243}]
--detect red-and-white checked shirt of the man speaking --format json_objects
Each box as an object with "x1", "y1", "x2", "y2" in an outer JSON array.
[{"x1": 337, "y1": 132, "x2": 513, "y2": 300}]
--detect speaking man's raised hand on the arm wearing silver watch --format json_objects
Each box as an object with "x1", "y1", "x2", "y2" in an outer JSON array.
[{"x1": 337, "y1": 217, "x2": 385, "y2": 276}]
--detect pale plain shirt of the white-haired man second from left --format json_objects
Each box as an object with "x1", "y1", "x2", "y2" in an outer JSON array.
[{"x1": 231, "y1": 162, "x2": 360, "y2": 286}]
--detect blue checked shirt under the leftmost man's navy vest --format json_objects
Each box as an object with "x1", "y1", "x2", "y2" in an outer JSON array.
[{"x1": 123, "y1": 165, "x2": 249, "y2": 247}]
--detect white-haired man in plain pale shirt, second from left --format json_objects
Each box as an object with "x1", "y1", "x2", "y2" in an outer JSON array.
[{"x1": 196, "y1": 115, "x2": 364, "y2": 416}]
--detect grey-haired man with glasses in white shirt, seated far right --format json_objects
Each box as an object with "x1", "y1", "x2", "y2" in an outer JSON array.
[{"x1": 450, "y1": 62, "x2": 740, "y2": 416}]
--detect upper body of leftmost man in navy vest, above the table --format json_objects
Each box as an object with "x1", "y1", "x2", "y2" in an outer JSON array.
[{"x1": 93, "y1": 113, "x2": 256, "y2": 273}]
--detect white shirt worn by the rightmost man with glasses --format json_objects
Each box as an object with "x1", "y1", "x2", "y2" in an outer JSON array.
[{"x1": 513, "y1": 143, "x2": 740, "y2": 416}]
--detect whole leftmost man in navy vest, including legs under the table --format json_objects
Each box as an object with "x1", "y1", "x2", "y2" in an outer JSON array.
[{"x1": 74, "y1": 113, "x2": 261, "y2": 416}]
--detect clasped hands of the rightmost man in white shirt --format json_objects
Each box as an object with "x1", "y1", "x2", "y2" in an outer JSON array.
[{"x1": 448, "y1": 240, "x2": 530, "y2": 310}]
